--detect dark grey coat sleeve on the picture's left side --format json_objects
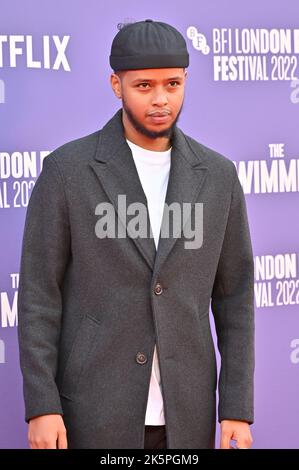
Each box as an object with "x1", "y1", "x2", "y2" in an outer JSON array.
[{"x1": 18, "y1": 152, "x2": 70, "y2": 422}]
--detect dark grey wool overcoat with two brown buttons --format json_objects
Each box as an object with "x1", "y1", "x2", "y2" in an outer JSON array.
[{"x1": 18, "y1": 109, "x2": 254, "y2": 449}]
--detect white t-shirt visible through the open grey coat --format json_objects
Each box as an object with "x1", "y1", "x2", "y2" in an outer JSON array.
[{"x1": 126, "y1": 139, "x2": 171, "y2": 426}]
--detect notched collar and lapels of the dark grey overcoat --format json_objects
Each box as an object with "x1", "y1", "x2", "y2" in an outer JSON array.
[{"x1": 90, "y1": 108, "x2": 207, "y2": 275}]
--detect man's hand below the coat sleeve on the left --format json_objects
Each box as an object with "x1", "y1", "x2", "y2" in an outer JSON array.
[{"x1": 28, "y1": 414, "x2": 67, "y2": 449}]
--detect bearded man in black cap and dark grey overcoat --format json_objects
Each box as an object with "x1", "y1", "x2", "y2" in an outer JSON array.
[{"x1": 18, "y1": 20, "x2": 254, "y2": 449}]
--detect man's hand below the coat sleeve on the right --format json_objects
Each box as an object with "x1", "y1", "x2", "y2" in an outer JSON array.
[{"x1": 220, "y1": 419, "x2": 252, "y2": 449}]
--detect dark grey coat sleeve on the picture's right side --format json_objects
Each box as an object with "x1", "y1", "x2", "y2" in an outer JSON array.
[{"x1": 211, "y1": 167, "x2": 255, "y2": 424}]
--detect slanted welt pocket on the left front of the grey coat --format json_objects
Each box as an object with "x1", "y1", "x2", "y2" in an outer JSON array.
[{"x1": 60, "y1": 315, "x2": 101, "y2": 399}]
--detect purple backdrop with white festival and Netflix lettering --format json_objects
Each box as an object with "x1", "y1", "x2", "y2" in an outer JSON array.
[{"x1": 0, "y1": 0, "x2": 299, "y2": 448}]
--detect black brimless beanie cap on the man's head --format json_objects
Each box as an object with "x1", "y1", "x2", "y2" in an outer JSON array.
[{"x1": 110, "y1": 20, "x2": 189, "y2": 71}]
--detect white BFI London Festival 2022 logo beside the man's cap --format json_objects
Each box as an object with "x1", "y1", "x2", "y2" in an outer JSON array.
[{"x1": 186, "y1": 26, "x2": 299, "y2": 104}]
